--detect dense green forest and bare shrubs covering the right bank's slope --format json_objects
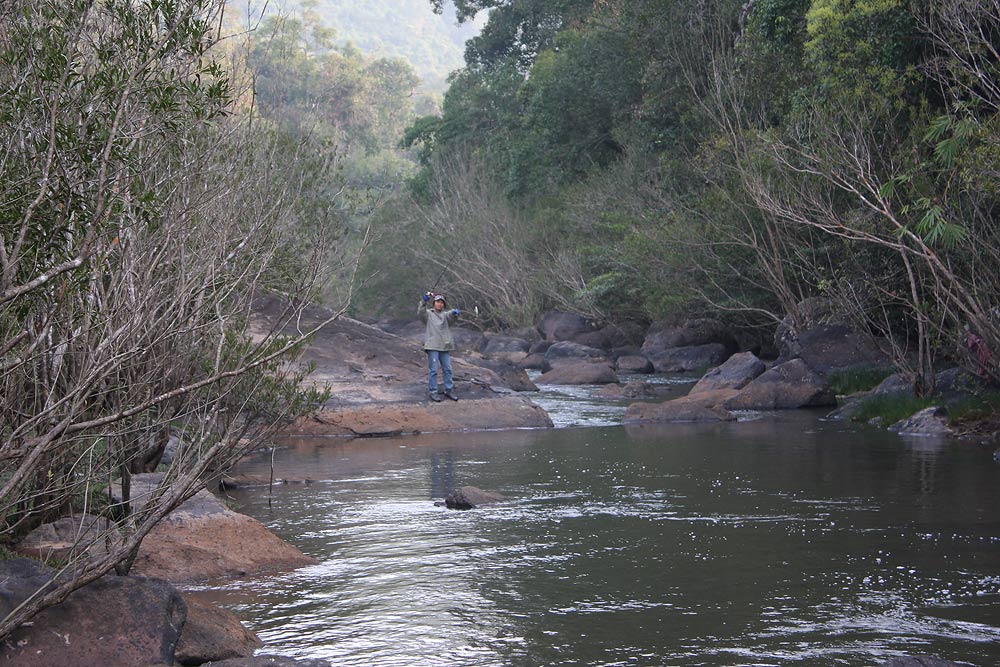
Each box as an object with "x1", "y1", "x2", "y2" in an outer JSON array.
[{"x1": 364, "y1": 0, "x2": 1000, "y2": 392}]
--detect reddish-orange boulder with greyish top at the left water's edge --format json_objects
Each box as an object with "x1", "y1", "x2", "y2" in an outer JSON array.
[{"x1": 121, "y1": 474, "x2": 316, "y2": 582}]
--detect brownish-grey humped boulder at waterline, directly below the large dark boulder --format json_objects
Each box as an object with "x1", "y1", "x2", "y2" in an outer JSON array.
[{"x1": 723, "y1": 359, "x2": 837, "y2": 410}]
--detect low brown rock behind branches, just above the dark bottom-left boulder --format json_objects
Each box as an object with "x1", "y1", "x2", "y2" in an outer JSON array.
[{"x1": 14, "y1": 514, "x2": 122, "y2": 561}]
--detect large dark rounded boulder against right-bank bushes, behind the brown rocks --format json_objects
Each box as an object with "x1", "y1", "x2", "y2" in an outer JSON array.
[{"x1": 775, "y1": 298, "x2": 892, "y2": 375}]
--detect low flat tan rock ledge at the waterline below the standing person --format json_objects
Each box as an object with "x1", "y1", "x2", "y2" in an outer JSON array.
[{"x1": 287, "y1": 396, "x2": 553, "y2": 437}]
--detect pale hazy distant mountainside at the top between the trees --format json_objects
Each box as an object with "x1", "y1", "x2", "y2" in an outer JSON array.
[{"x1": 287, "y1": 0, "x2": 485, "y2": 91}]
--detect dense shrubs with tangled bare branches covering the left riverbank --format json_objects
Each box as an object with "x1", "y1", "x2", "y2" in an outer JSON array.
[{"x1": 0, "y1": 0, "x2": 415, "y2": 637}]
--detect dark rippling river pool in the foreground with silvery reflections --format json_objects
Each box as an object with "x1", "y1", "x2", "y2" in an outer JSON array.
[{"x1": 200, "y1": 412, "x2": 1000, "y2": 667}]
